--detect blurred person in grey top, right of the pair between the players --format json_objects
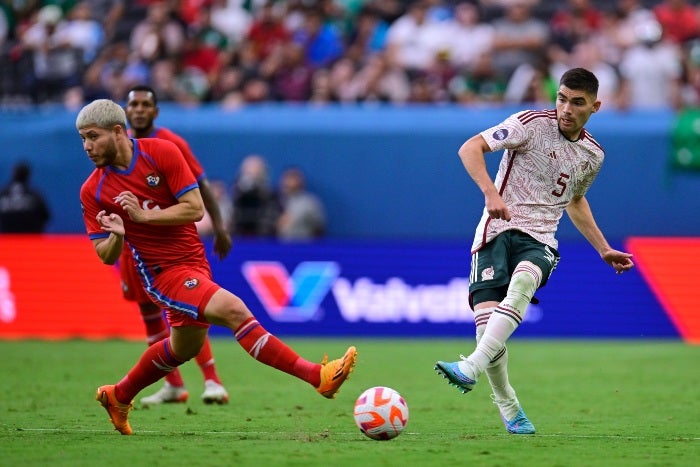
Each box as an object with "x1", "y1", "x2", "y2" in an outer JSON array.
[{"x1": 277, "y1": 167, "x2": 326, "y2": 240}]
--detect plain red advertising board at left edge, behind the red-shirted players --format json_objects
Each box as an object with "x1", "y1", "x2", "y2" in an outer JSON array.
[{"x1": 0, "y1": 234, "x2": 145, "y2": 340}]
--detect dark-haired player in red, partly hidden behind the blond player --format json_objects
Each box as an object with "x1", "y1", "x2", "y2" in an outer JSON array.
[{"x1": 119, "y1": 85, "x2": 232, "y2": 406}]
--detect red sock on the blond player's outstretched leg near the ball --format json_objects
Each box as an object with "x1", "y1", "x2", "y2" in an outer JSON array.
[{"x1": 234, "y1": 318, "x2": 321, "y2": 387}]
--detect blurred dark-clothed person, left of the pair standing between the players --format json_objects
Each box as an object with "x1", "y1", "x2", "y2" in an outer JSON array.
[{"x1": 233, "y1": 154, "x2": 280, "y2": 237}]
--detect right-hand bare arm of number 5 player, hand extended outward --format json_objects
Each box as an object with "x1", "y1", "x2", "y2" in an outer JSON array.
[{"x1": 566, "y1": 196, "x2": 634, "y2": 274}]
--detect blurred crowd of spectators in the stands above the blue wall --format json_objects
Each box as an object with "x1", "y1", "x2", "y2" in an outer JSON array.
[{"x1": 0, "y1": 0, "x2": 700, "y2": 109}]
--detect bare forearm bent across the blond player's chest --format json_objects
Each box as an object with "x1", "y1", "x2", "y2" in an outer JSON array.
[{"x1": 114, "y1": 188, "x2": 204, "y2": 225}]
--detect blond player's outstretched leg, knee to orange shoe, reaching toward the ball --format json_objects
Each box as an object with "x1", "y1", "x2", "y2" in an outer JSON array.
[{"x1": 204, "y1": 288, "x2": 357, "y2": 398}]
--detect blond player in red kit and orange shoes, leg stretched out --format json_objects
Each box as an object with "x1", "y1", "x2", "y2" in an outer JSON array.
[{"x1": 76, "y1": 99, "x2": 357, "y2": 435}]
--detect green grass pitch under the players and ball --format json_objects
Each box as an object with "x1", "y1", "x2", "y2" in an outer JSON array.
[{"x1": 0, "y1": 338, "x2": 700, "y2": 467}]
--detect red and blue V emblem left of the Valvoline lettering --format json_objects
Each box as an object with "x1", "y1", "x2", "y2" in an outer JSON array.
[{"x1": 242, "y1": 261, "x2": 340, "y2": 322}]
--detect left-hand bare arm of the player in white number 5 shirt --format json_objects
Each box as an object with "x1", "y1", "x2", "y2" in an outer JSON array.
[{"x1": 458, "y1": 134, "x2": 510, "y2": 221}]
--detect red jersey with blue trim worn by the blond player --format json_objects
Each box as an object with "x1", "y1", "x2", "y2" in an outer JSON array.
[{"x1": 80, "y1": 138, "x2": 208, "y2": 269}]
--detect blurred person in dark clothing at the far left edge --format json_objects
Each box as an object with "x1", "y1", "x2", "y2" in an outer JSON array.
[{"x1": 0, "y1": 162, "x2": 51, "y2": 233}]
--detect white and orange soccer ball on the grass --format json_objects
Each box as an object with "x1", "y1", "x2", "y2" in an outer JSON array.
[{"x1": 353, "y1": 386, "x2": 408, "y2": 440}]
